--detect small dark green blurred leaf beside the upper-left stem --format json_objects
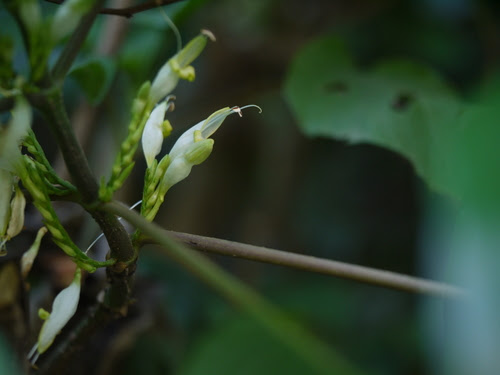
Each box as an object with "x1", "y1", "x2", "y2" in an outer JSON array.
[{"x1": 70, "y1": 57, "x2": 116, "y2": 105}]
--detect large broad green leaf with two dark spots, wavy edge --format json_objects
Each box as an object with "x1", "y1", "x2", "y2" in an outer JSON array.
[{"x1": 284, "y1": 37, "x2": 461, "y2": 195}]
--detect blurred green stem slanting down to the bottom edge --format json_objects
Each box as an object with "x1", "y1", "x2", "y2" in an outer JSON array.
[{"x1": 103, "y1": 202, "x2": 359, "y2": 375}]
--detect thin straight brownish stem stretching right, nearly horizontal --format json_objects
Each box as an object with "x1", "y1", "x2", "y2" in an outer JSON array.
[{"x1": 163, "y1": 231, "x2": 466, "y2": 298}]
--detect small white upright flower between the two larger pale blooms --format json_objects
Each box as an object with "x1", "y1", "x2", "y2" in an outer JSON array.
[{"x1": 142, "y1": 101, "x2": 172, "y2": 167}]
